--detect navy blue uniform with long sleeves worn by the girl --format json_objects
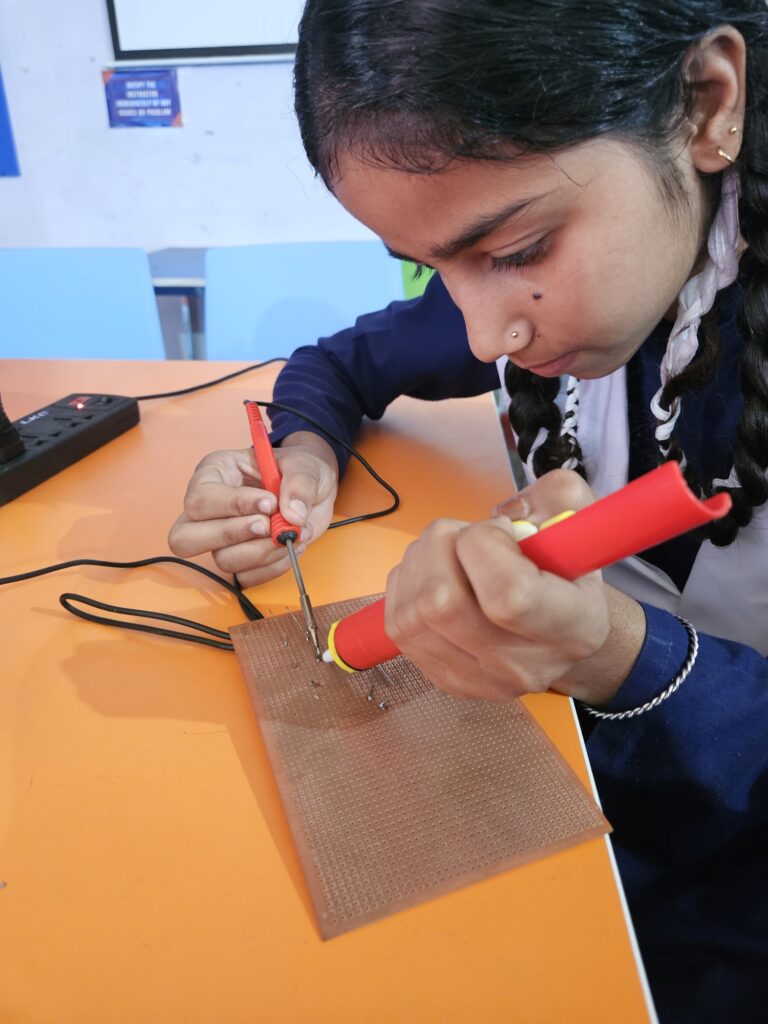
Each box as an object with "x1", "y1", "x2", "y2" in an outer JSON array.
[{"x1": 272, "y1": 276, "x2": 768, "y2": 1024}]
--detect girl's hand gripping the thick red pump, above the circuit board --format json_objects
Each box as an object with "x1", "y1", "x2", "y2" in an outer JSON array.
[{"x1": 385, "y1": 470, "x2": 644, "y2": 702}]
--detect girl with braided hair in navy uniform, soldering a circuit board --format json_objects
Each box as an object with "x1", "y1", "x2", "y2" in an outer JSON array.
[{"x1": 170, "y1": 0, "x2": 768, "y2": 1024}]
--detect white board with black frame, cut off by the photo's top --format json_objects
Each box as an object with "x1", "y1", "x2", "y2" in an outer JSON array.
[{"x1": 106, "y1": 0, "x2": 304, "y2": 60}]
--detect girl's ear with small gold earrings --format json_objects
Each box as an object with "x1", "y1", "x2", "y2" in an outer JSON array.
[{"x1": 685, "y1": 25, "x2": 746, "y2": 174}]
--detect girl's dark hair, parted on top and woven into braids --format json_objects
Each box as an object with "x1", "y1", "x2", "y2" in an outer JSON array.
[{"x1": 295, "y1": 0, "x2": 768, "y2": 545}]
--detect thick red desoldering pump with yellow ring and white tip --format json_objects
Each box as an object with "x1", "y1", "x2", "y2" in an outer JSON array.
[{"x1": 323, "y1": 462, "x2": 731, "y2": 672}]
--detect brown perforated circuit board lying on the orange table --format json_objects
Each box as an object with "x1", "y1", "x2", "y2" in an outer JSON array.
[{"x1": 231, "y1": 598, "x2": 609, "y2": 938}]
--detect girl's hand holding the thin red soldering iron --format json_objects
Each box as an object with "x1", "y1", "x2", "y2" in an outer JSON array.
[{"x1": 168, "y1": 432, "x2": 339, "y2": 587}]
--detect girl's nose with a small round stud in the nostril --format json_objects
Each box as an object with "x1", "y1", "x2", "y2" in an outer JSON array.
[{"x1": 443, "y1": 274, "x2": 534, "y2": 362}]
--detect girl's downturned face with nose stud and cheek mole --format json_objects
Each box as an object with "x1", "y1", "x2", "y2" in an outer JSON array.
[{"x1": 334, "y1": 139, "x2": 709, "y2": 378}]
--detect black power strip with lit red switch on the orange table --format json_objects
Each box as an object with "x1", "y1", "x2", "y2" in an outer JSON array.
[{"x1": 0, "y1": 394, "x2": 138, "y2": 505}]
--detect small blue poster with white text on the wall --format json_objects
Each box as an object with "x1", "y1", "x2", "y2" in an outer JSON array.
[{"x1": 101, "y1": 68, "x2": 182, "y2": 128}]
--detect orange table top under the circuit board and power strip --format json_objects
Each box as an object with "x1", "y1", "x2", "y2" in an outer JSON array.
[{"x1": 0, "y1": 359, "x2": 653, "y2": 1024}]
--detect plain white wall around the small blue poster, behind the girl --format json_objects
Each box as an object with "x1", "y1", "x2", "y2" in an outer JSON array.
[{"x1": 0, "y1": 0, "x2": 371, "y2": 250}]
